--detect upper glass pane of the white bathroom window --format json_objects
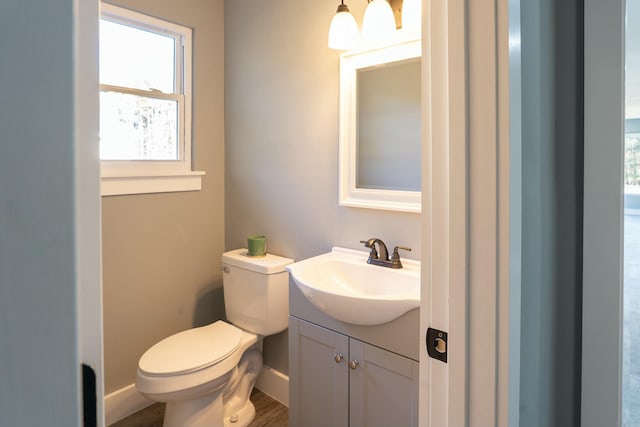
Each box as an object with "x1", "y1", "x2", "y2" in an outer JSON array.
[{"x1": 100, "y1": 19, "x2": 176, "y2": 93}]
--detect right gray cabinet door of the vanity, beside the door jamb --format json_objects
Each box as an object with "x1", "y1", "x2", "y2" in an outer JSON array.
[{"x1": 349, "y1": 339, "x2": 419, "y2": 427}]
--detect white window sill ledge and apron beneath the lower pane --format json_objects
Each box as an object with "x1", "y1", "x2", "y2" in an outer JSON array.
[{"x1": 101, "y1": 171, "x2": 205, "y2": 196}]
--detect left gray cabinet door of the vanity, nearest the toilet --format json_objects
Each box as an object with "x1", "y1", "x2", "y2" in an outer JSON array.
[{"x1": 289, "y1": 317, "x2": 350, "y2": 427}]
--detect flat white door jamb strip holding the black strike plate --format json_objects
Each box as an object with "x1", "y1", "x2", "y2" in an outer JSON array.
[{"x1": 419, "y1": 0, "x2": 468, "y2": 427}]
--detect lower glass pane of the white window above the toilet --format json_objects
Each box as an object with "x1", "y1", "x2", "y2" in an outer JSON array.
[{"x1": 100, "y1": 92, "x2": 180, "y2": 160}]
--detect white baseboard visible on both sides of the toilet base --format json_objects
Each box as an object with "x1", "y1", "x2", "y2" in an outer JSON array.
[{"x1": 104, "y1": 365, "x2": 289, "y2": 426}]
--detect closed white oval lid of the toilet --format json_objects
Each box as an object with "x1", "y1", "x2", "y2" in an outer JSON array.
[{"x1": 138, "y1": 320, "x2": 242, "y2": 375}]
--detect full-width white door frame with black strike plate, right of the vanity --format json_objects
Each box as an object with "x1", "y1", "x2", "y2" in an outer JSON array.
[{"x1": 420, "y1": 0, "x2": 519, "y2": 427}]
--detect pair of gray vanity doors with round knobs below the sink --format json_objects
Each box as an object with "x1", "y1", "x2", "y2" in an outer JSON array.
[{"x1": 289, "y1": 316, "x2": 418, "y2": 427}]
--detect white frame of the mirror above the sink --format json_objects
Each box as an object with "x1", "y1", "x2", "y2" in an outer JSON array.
[{"x1": 339, "y1": 39, "x2": 422, "y2": 212}]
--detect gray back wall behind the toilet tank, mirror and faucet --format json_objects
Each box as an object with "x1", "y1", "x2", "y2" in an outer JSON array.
[{"x1": 224, "y1": 0, "x2": 420, "y2": 372}]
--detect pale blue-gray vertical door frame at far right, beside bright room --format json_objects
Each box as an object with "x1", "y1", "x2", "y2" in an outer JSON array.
[{"x1": 581, "y1": 0, "x2": 625, "y2": 427}]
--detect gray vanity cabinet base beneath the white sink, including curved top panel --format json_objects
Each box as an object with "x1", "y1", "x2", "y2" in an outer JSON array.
[{"x1": 289, "y1": 278, "x2": 420, "y2": 427}]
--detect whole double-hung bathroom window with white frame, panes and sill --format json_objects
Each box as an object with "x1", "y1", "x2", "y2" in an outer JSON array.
[{"x1": 100, "y1": 3, "x2": 204, "y2": 195}]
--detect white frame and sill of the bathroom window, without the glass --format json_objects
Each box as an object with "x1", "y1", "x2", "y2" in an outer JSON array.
[{"x1": 100, "y1": 3, "x2": 205, "y2": 196}]
